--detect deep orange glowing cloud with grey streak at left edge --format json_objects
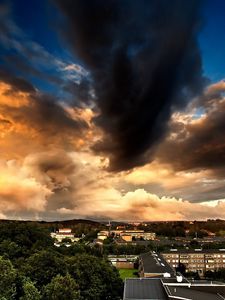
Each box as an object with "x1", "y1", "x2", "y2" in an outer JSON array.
[{"x1": 0, "y1": 78, "x2": 93, "y2": 159}]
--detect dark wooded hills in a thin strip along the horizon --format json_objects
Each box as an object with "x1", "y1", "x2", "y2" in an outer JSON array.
[{"x1": 0, "y1": 219, "x2": 225, "y2": 237}]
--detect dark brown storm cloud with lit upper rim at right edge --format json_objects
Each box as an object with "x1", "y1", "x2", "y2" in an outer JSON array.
[{"x1": 157, "y1": 82, "x2": 225, "y2": 177}]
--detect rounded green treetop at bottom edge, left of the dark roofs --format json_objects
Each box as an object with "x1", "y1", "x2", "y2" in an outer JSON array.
[{"x1": 43, "y1": 273, "x2": 80, "y2": 300}]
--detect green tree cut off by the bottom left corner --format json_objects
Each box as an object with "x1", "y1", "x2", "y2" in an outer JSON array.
[{"x1": 0, "y1": 256, "x2": 16, "y2": 300}]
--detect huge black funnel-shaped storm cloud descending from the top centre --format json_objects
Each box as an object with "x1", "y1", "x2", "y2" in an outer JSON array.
[{"x1": 56, "y1": 0, "x2": 203, "y2": 170}]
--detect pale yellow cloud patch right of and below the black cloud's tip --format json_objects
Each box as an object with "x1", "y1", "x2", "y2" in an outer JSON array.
[{"x1": 123, "y1": 160, "x2": 225, "y2": 202}]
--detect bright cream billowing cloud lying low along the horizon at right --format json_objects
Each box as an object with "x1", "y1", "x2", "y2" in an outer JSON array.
[{"x1": 58, "y1": 189, "x2": 225, "y2": 221}]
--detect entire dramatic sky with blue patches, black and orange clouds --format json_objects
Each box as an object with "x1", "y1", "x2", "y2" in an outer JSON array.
[{"x1": 0, "y1": 0, "x2": 225, "y2": 221}]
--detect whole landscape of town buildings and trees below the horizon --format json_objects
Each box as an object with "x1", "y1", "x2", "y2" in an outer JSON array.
[{"x1": 0, "y1": 219, "x2": 225, "y2": 300}]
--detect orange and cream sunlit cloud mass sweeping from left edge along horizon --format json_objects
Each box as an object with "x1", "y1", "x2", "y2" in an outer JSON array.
[{"x1": 0, "y1": 82, "x2": 225, "y2": 220}]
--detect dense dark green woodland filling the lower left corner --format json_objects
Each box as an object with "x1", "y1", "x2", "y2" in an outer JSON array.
[{"x1": 0, "y1": 222, "x2": 123, "y2": 300}]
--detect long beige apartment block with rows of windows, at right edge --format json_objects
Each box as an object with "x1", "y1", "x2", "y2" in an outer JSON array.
[{"x1": 162, "y1": 249, "x2": 225, "y2": 276}]
